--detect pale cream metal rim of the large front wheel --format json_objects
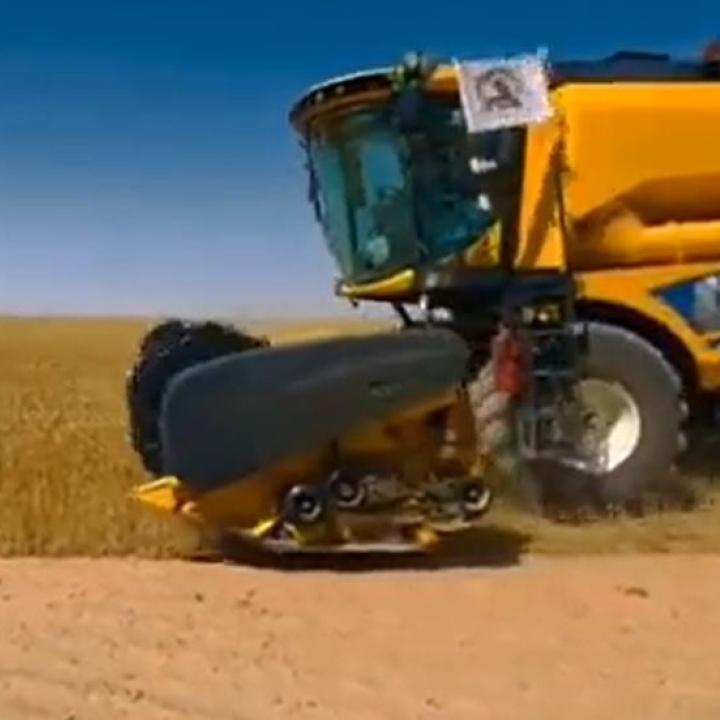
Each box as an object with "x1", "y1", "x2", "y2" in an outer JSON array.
[{"x1": 576, "y1": 378, "x2": 642, "y2": 474}]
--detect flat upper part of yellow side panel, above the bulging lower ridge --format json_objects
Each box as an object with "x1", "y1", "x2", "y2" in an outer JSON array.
[{"x1": 554, "y1": 82, "x2": 720, "y2": 224}]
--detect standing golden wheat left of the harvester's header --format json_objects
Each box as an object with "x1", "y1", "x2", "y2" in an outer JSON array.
[{"x1": 0, "y1": 319, "x2": 188, "y2": 555}]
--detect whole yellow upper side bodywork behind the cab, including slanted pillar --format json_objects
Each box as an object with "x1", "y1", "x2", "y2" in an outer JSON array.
[{"x1": 517, "y1": 82, "x2": 720, "y2": 271}]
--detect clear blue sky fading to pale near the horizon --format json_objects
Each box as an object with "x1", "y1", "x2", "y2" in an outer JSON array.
[{"x1": 0, "y1": 0, "x2": 720, "y2": 316}]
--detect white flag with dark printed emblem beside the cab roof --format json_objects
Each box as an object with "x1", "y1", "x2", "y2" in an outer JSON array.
[{"x1": 457, "y1": 55, "x2": 552, "y2": 133}]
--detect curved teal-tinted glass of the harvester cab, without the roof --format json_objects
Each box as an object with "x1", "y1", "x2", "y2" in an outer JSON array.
[{"x1": 308, "y1": 101, "x2": 494, "y2": 282}]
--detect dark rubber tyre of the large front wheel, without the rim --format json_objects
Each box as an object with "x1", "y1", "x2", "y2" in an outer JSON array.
[{"x1": 528, "y1": 322, "x2": 684, "y2": 514}]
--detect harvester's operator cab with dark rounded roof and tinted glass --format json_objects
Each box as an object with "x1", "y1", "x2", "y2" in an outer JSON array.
[{"x1": 291, "y1": 55, "x2": 522, "y2": 294}]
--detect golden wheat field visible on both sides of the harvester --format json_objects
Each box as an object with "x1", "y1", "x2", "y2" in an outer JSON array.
[{"x1": 0, "y1": 318, "x2": 720, "y2": 557}]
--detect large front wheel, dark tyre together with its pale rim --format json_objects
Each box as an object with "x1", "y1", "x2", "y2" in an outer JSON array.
[{"x1": 529, "y1": 322, "x2": 684, "y2": 513}]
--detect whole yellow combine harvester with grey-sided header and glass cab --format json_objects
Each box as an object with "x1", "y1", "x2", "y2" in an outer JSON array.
[{"x1": 128, "y1": 45, "x2": 720, "y2": 550}]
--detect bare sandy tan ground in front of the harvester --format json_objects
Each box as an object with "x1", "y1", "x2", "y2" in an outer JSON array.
[{"x1": 0, "y1": 556, "x2": 720, "y2": 720}]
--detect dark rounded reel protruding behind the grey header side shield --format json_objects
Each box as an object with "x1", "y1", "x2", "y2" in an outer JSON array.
[{"x1": 126, "y1": 320, "x2": 268, "y2": 476}]
